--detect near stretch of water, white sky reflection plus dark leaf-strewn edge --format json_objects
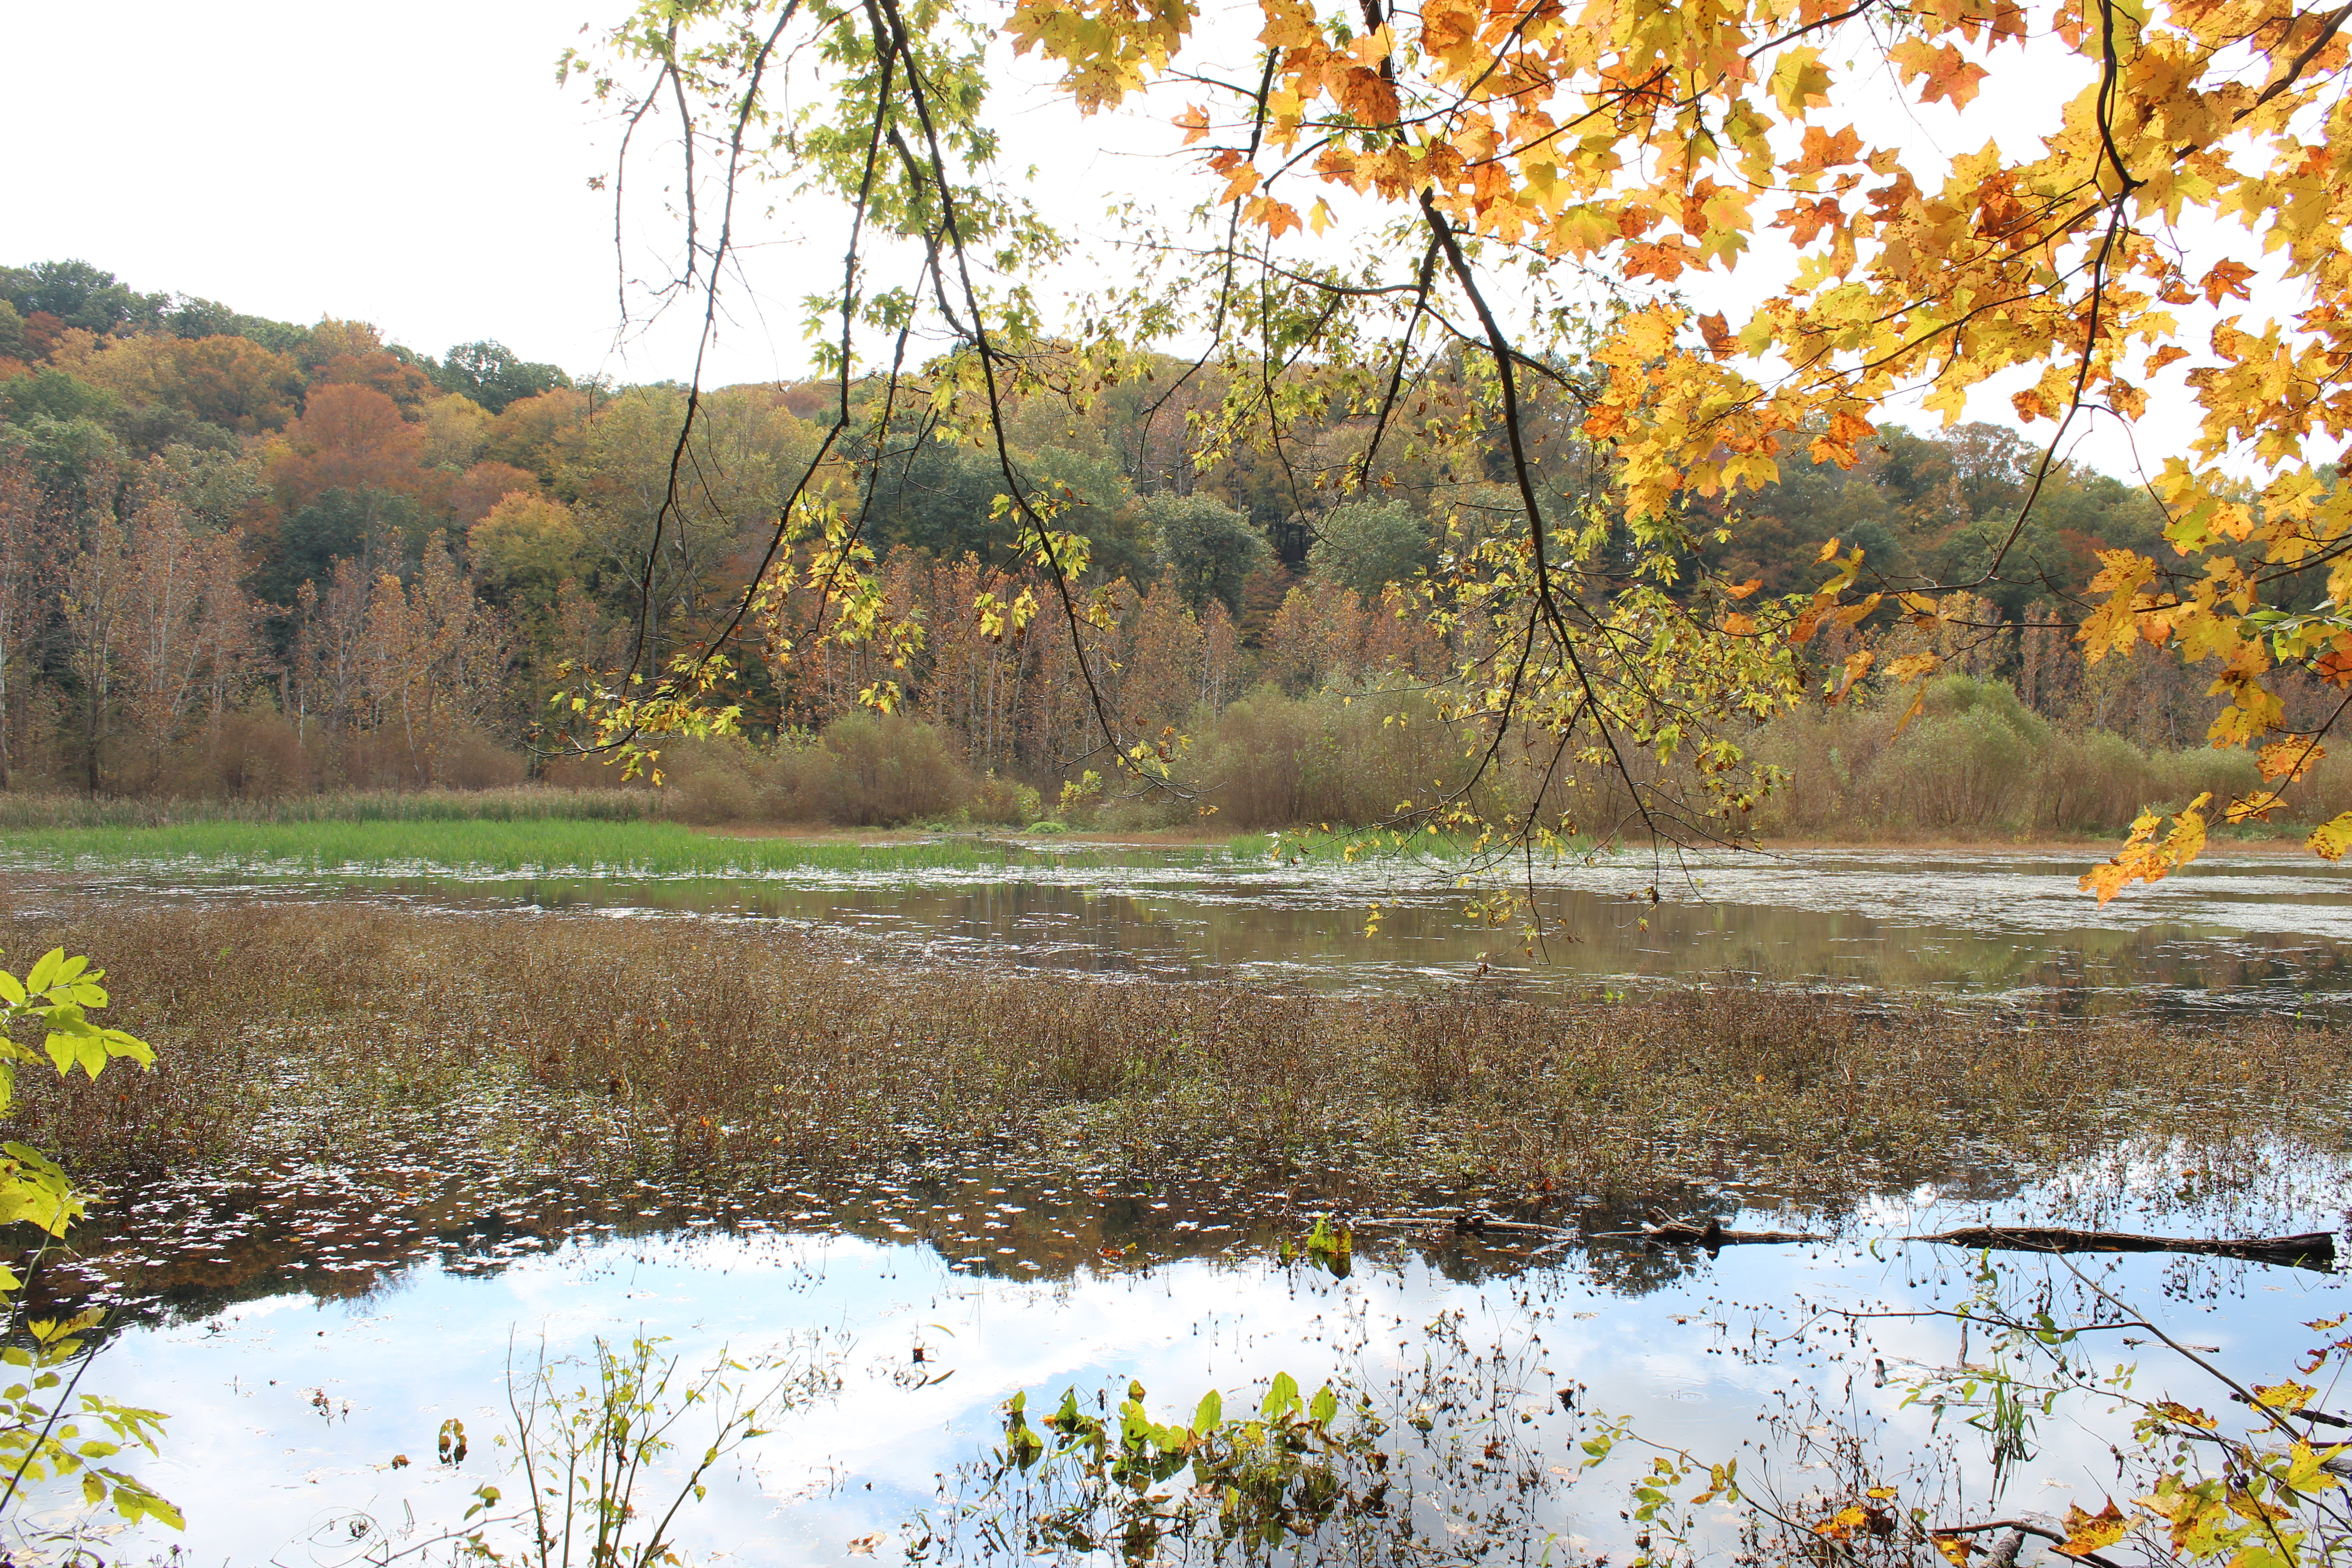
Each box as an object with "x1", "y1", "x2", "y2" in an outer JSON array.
[{"x1": 69, "y1": 1156, "x2": 2342, "y2": 1563}]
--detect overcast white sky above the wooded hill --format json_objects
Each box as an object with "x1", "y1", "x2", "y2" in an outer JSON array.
[{"x1": 0, "y1": 0, "x2": 2258, "y2": 484}]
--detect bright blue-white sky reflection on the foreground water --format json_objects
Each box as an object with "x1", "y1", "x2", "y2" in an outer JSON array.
[{"x1": 78, "y1": 1187, "x2": 2336, "y2": 1563}]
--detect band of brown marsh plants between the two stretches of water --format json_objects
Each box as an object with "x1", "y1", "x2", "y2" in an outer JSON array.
[{"x1": 0, "y1": 905, "x2": 2352, "y2": 1206}]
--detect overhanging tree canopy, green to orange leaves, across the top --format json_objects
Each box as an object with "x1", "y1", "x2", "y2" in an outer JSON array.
[{"x1": 567, "y1": 0, "x2": 2352, "y2": 874}]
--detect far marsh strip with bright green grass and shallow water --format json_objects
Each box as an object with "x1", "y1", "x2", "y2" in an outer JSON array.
[{"x1": 0, "y1": 820, "x2": 2352, "y2": 1015}]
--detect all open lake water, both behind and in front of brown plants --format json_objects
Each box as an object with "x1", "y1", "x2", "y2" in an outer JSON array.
[{"x1": 7, "y1": 851, "x2": 2352, "y2": 1566}]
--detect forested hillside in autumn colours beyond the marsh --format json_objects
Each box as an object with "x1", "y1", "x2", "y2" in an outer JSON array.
[{"x1": 0, "y1": 261, "x2": 2314, "y2": 828}]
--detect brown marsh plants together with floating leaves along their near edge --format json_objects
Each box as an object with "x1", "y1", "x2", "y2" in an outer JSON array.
[{"x1": 0, "y1": 903, "x2": 2352, "y2": 1312}]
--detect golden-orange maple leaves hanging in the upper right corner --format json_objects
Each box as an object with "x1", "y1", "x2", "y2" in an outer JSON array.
[{"x1": 992, "y1": 0, "x2": 2352, "y2": 879}]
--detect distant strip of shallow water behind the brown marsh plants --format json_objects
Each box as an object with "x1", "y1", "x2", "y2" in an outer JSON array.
[{"x1": 12, "y1": 848, "x2": 2352, "y2": 1013}]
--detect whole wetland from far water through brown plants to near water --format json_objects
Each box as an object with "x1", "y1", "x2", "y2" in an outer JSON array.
[{"x1": 0, "y1": 827, "x2": 2352, "y2": 1563}]
